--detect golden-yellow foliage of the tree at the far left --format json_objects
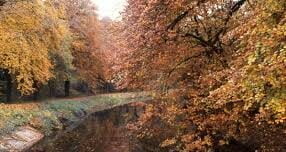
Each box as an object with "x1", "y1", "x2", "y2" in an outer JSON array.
[{"x1": 0, "y1": 0, "x2": 69, "y2": 95}]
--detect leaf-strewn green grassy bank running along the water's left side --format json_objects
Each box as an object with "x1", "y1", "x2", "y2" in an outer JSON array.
[{"x1": 0, "y1": 93, "x2": 148, "y2": 135}]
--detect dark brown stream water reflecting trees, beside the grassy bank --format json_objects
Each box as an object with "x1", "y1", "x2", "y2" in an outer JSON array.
[{"x1": 29, "y1": 104, "x2": 144, "y2": 152}]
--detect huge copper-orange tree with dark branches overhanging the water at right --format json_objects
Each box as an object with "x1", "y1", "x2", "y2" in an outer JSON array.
[{"x1": 122, "y1": 0, "x2": 286, "y2": 151}]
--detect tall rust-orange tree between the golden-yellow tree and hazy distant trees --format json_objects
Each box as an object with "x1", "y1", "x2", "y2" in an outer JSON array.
[{"x1": 62, "y1": 0, "x2": 104, "y2": 92}]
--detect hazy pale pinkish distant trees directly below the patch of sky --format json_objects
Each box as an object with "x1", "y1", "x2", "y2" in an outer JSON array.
[{"x1": 100, "y1": 18, "x2": 129, "y2": 90}]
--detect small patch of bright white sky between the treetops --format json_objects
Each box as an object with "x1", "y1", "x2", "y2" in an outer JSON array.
[{"x1": 92, "y1": 0, "x2": 126, "y2": 20}]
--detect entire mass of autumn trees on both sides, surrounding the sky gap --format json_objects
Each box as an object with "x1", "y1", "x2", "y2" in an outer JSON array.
[{"x1": 0, "y1": 0, "x2": 286, "y2": 152}]
